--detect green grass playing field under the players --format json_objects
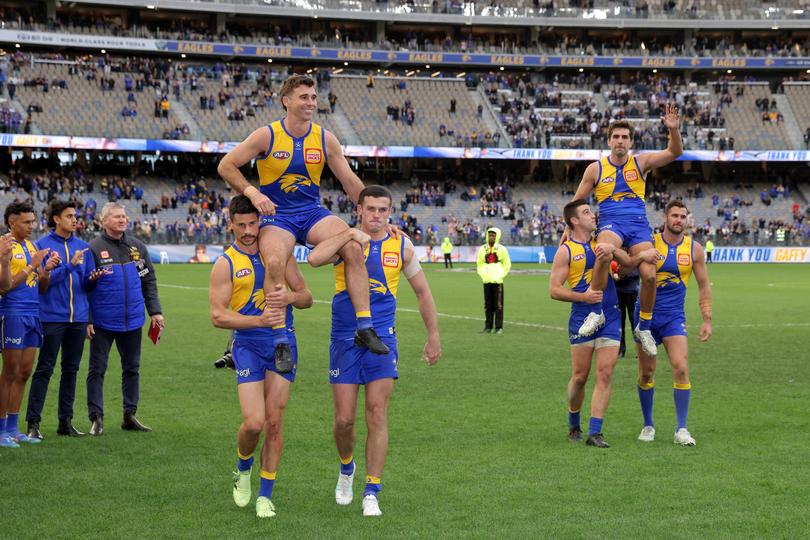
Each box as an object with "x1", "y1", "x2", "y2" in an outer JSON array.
[{"x1": 0, "y1": 265, "x2": 810, "y2": 538}]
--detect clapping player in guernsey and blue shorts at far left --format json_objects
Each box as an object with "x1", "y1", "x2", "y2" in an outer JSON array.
[{"x1": 0, "y1": 202, "x2": 61, "y2": 448}]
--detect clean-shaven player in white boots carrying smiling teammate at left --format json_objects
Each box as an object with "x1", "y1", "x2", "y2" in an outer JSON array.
[{"x1": 309, "y1": 186, "x2": 442, "y2": 516}]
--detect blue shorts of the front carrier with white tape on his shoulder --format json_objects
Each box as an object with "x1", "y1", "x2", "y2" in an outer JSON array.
[{"x1": 329, "y1": 336, "x2": 399, "y2": 384}]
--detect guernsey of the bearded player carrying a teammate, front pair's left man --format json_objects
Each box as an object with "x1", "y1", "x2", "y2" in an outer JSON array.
[{"x1": 223, "y1": 245, "x2": 293, "y2": 342}]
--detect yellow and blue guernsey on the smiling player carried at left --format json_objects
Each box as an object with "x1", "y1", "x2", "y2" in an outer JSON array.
[{"x1": 256, "y1": 120, "x2": 326, "y2": 216}]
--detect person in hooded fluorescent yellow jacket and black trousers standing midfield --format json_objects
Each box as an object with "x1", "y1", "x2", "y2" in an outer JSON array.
[{"x1": 478, "y1": 227, "x2": 512, "y2": 334}]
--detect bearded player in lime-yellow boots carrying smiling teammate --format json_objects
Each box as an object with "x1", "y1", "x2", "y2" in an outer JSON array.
[{"x1": 209, "y1": 195, "x2": 312, "y2": 517}]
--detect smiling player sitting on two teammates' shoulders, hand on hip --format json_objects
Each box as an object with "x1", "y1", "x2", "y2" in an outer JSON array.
[{"x1": 217, "y1": 75, "x2": 388, "y2": 373}]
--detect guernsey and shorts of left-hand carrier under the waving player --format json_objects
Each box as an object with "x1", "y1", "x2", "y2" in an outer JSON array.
[{"x1": 563, "y1": 239, "x2": 621, "y2": 345}]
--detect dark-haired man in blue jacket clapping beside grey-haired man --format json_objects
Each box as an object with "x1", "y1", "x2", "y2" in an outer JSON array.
[{"x1": 26, "y1": 200, "x2": 99, "y2": 439}]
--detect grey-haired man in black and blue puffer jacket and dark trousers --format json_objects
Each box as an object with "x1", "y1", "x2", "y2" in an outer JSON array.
[{"x1": 87, "y1": 202, "x2": 163, "y2": 436}]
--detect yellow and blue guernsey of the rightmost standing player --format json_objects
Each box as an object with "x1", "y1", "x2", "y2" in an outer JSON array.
[{"x1": 653, "y1": 233, "x2": 694, "y2": 317}]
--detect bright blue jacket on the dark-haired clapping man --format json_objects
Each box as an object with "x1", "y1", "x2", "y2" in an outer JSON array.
[{"x1": 36, "y1": 232, "x2": 96, "y2": 323}]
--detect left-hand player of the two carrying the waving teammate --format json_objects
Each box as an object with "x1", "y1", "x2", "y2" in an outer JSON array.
[{"x1": 549, "y1": 199, "x2": 654, "y2": 448}]
